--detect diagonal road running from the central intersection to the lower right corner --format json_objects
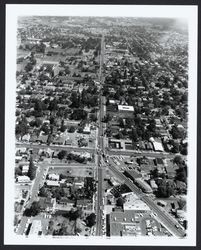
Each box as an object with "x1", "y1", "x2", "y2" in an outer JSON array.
[{"x1": 107, "y1": 159, "x2": 186, "y2": 238}]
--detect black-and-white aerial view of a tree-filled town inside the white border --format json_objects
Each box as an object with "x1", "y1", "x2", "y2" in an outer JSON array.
[{"x1": 12, "y1": 13, "x2": 189, "y2": 239}]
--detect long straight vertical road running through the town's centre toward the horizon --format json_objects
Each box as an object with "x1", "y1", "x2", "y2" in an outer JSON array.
[{"x1": 96, "y1": 36, "x2": 105, "y2": 236}]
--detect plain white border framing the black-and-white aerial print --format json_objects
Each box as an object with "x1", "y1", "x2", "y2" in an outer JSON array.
[{"x1": 4, "y1": 4, "x2": 198, "y2": 246}]
